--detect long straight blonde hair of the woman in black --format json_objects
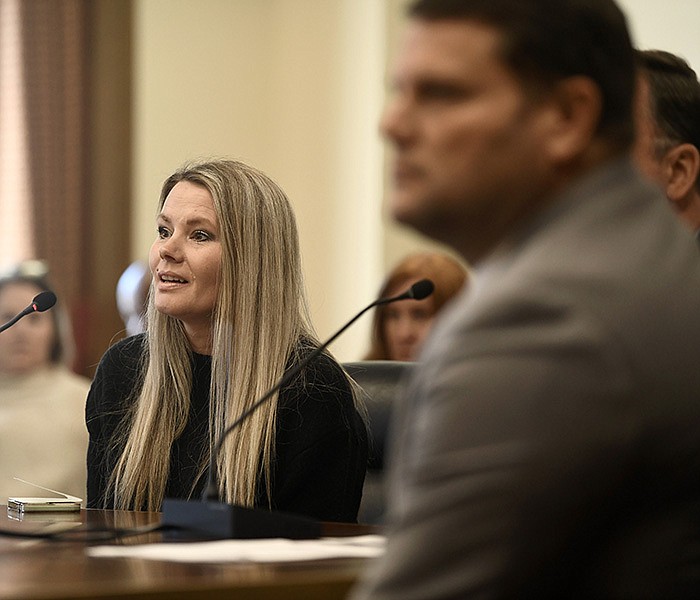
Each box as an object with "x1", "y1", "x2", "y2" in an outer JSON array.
[{"x1": 110, "y1": 160, "x2": 315, "y2": 510}]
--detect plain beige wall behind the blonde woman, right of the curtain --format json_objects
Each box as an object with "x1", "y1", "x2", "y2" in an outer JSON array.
[{"x1": 132, "y1": 0, "x2": 700, "y2": 360}]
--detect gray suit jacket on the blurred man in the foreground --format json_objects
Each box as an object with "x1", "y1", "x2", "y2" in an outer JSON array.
[{"x1": 355, "y1": 160, "x2": 700, "y2": 600}]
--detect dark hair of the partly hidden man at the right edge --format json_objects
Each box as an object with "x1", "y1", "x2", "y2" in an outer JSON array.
[{"x1": 637, "y1": 50, "x2": 700, "y2": 158}]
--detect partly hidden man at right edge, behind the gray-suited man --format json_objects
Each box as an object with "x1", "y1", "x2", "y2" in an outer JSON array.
[{"x1": 635, "y1": 50, "x2": 700, "y2": 233}]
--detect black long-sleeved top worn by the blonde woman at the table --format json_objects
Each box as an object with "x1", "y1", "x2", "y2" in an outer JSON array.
[{"x1": 86, "y1": 334, "x2": 368, "y2": 522}]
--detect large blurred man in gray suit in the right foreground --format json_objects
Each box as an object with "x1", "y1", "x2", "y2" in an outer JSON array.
[{"x1": 354, "y1": 0, "x2": 700, "y2": 600}]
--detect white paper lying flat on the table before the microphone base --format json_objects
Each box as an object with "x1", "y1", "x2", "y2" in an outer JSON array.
[{"x1": 86, "y1": 535, "x2": 386, "y2": 563}]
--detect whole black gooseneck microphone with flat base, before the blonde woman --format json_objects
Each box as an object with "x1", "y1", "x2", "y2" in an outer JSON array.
[{"x1": 161, "y1": 279, "x2": 435, "y2": 539}]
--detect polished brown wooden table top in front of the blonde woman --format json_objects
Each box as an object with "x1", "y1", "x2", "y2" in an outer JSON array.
[{"x1": 0, "y1": 505, "x2": 374, "y2": 600}]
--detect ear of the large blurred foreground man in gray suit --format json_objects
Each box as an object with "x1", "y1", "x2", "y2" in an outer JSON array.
[{"x1": 545, "y1": 76, "x2": 603, "y2": 163}]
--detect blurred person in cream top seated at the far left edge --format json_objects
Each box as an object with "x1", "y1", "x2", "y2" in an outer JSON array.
[{"x1": 0, "y1": 263, "x2": 90, "y2": 504}]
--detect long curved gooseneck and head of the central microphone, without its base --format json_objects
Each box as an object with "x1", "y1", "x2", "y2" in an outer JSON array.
[{"x1": 203, "y1": 279, "x2": 435, "y2": 501}]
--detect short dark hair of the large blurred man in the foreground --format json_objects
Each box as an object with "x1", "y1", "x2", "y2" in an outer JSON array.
[{"x1": 408, "y1": 0, "x2": 635, "y2": 149}]
